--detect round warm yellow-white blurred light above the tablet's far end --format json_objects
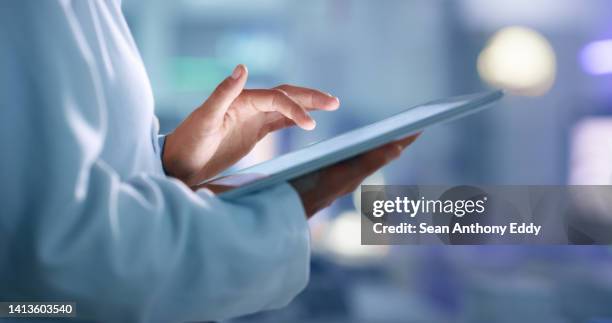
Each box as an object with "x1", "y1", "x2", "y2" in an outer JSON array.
[{"x1": 478, "y1": 27, "x2": 557, "y2": 96}]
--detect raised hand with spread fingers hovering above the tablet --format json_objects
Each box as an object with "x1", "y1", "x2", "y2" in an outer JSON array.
[{"x1": 162, "y1": 65, "x2": 340, "y2": 186}]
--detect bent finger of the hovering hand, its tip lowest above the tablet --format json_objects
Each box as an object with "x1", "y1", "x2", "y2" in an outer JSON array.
[{"x1": 244, "y1": 89, "x2": 316, "y2": 130}]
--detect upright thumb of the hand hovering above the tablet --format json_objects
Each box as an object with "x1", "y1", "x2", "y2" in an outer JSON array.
[{"x1": 198, "y1": 64, "x2": 249, "y2": 120}]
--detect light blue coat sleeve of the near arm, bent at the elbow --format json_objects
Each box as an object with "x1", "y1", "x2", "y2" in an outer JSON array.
[{"x1": 0, "y1": 1, "x2": 309, "y2": 322}]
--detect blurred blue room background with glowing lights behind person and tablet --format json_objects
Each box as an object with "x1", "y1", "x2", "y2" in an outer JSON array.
[{"x1": 124, "y1": 0, "x2": 612, "y2": 322}]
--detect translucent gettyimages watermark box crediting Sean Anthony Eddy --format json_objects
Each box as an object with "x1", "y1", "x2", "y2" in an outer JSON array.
[{"x1": 361, "y1": 185, "x2": 612, "y2": 245}]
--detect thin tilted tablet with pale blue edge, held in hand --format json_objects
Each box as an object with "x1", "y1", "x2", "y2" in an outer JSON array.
[{"x1": 203, "y1": 91, "x2": 503, "y2": 199}]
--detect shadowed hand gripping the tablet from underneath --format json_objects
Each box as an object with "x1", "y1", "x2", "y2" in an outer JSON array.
[{"x1": 290, "y1": 133, "x2": 420, "y2": 218}]
